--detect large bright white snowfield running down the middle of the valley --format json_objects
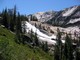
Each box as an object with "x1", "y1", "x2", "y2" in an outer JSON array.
[{"x1": 22, "y1": 21, "x2": 64, "y2": 45}]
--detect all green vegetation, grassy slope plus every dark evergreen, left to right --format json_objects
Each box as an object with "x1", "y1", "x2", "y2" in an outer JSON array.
[{"x1": 0, "y1": 6, "x2": 80, "y2": 60}]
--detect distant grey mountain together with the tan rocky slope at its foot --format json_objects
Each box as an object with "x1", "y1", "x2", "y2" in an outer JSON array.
[{"x1": 27, "y1": 5, "x2": 80, "y2": 35}]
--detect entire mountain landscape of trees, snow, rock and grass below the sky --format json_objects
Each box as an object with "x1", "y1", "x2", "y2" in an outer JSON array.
[{"x1": 0, "y1": 6, "x2": 80, "y2": 60}]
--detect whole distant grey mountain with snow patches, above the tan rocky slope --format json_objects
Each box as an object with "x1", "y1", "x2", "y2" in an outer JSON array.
[{"x1": 27, "y1": 6, "x2": 80, "y2": 27}]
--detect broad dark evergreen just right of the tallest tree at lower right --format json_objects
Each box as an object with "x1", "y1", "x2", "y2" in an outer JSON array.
[{"x1": 64, "y1": 34, "x2": 73, "y2": 60}]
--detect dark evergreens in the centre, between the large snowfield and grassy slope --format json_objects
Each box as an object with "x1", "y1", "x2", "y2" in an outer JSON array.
[{"x1": 24, "y1": 29, "x2": 49, "y2": 53}]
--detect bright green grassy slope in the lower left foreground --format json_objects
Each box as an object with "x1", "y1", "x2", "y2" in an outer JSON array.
[{"x1": 0, "y1": 27, "x2": 53, "y2": 60}]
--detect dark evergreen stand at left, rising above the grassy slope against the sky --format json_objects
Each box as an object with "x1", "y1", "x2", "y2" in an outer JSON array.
[{"x1": 0, "y1": 6, "x2": 28, "y2": 43}]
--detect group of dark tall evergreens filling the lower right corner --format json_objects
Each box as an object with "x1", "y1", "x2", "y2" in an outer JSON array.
[{"x1": 54, "y1": 29, "x2": 80, "y2": 60}]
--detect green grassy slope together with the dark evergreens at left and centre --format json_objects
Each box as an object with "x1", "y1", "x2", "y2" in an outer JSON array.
[{"x1": 0, "y1": 6, "x2": 53, "y2": 60}]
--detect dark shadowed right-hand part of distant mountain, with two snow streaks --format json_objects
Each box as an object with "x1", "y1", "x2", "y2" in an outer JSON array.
[{"x1": 47, "y1": 6, "x2": 80, "y2": 27}]
